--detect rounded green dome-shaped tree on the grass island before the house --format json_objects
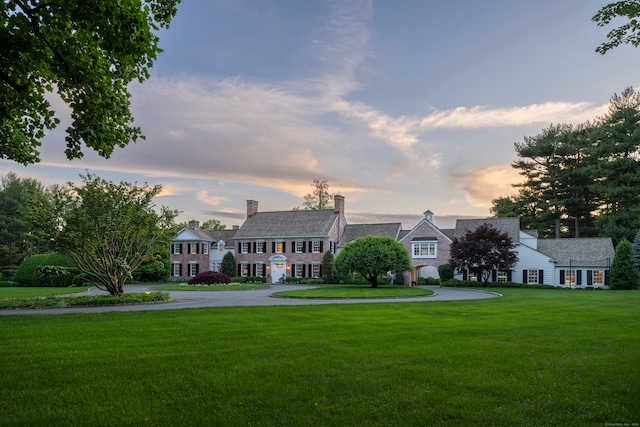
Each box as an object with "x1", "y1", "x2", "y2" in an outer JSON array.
[{"x1": 335, "y1": 236, "x2": 412, "y2": 288}]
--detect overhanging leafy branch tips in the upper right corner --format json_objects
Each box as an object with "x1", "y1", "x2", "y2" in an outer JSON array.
[{"x1": 591, "y1": 0, "x2": 640, "y2": 55}]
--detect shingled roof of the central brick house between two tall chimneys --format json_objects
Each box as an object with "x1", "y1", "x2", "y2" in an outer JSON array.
[{"x1": 233, "y1": 209, "x2": 339, "y2": 240}]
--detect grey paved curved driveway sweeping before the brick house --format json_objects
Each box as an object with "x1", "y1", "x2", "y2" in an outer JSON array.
[{"x1": 0, "y1": 285, "x2": 500, "y2": 315}]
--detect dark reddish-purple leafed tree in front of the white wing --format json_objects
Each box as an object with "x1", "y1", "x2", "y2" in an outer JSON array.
[{"x1": 449, "y1": 223, "x2": 518, "y2": 286}]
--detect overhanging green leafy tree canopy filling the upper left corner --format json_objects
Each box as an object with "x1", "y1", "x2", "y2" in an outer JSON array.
[{"x1": 0, "y1": 0, "x2": 180, "y2": 165}]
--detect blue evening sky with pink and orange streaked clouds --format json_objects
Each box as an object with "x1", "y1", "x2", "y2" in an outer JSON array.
[{"x1": 0, "y1": 0, "x2": 640, "y2": 229}]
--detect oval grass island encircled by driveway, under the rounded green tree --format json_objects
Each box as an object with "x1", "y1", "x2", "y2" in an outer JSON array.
[{"x1": 273, "y1": 285, "x2": 434, "y2": 298}]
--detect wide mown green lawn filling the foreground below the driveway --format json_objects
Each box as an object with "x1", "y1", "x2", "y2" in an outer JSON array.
[{"x1": 0, "y1": 289, "x2": 640, "y2": 426}]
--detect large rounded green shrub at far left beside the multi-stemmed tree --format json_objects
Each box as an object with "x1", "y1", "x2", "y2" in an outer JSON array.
[{"x1": 13, "y1": 252, "x2": 80, "y2": 287}]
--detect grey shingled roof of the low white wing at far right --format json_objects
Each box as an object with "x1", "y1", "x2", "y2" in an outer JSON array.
[{"x1": 538, "y1": 237, "x2": 614, "y2": 266}]
